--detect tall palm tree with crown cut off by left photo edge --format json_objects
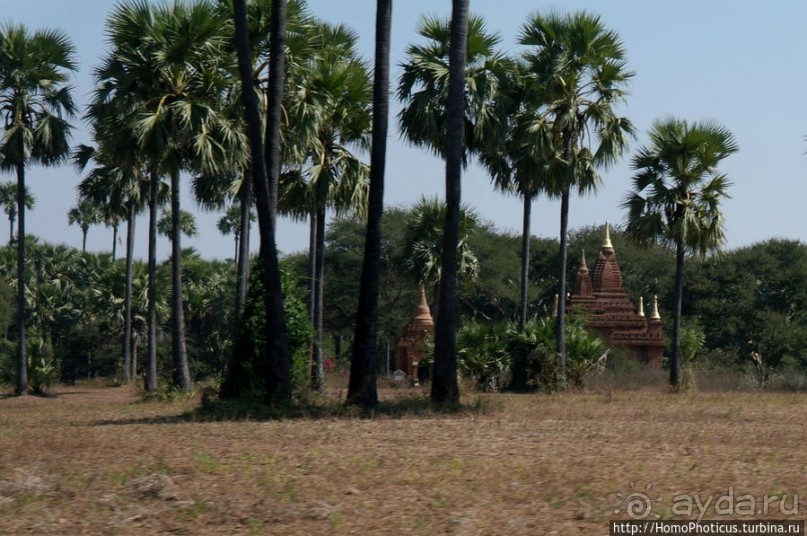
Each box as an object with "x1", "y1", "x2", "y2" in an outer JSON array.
[{"x1": 0, "y1": 23, "x2": 76, "y2": 395}]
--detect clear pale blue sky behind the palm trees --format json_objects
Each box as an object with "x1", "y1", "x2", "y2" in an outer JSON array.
[{"x1": 0, "y1": 0, "x2": 807, "y2": 258}]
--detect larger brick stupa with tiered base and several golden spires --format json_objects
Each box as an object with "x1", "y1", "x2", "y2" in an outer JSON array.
[{"x1": 567, "y1": 223, "x2": 664, "y2": 367}]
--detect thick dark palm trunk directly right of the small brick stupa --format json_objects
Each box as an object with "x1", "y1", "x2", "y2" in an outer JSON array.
[{"x1": 431, "y1": 0, "x2": 469, "y2": 403}]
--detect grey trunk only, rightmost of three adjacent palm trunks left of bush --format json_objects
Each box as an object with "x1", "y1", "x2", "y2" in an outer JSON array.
[{"x1": 171, "y1": 169, "x2": 191, "y2": 391}]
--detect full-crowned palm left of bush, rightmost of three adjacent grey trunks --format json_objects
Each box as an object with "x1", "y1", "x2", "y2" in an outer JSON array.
[{"x1": 98, "y1": 0, "x2": 244, "y2": 390}]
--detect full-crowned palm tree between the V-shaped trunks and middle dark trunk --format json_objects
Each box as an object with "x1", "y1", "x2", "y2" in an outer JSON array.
[{"x1": 281, "y1": 23, "x2": 372, "y2": 389}]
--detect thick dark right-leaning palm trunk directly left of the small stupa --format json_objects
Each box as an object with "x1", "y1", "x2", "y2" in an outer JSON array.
[{"x1": 347, "y1": 0, "x2": 392, "y2": 408}]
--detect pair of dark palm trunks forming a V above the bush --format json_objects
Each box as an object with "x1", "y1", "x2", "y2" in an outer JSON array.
[{"x1": 233, "y1": 0, "x2": 291, "y2": 404}]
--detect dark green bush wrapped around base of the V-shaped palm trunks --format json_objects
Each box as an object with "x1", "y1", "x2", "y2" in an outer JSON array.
[{"x1": 221, "y1": 262, "x2": 313, "y2": 400}]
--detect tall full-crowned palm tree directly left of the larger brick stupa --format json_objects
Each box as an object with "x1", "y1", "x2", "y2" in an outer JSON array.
[{"x1": 519, "y1": 12, "x2": 634, "y2": 385}]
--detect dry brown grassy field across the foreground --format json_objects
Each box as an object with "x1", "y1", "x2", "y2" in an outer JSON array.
[{"x1": 0, "y1": 378, "x2": 807, "y2": 535}]
